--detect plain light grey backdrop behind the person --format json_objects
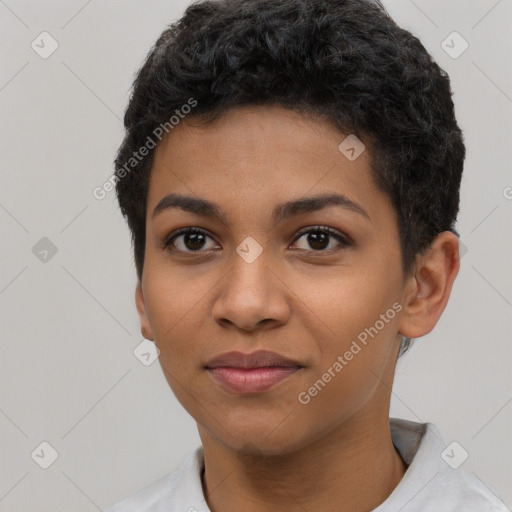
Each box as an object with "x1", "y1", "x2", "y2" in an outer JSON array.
[{"x1": 0, "y1": 0, "x2": 512, "y2": 512}]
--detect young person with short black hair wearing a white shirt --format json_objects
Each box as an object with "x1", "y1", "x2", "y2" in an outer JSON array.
[{"x1": 105, "y1": 0, "x2": 506, "y2": 512}]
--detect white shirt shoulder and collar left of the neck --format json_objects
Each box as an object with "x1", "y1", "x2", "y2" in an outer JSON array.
[{"x1": 105, "y1": 448, "x2": 208, "y2": 512}]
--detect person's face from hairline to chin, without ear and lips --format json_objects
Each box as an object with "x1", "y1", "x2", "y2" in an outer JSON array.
[{"x1": 136, "y1": 106, "x2": 412, "y2": 454}]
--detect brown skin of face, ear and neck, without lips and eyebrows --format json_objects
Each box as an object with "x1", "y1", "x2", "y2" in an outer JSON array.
[{"x1": 136, "y1": 106, "x2": 459, "y2": 512}]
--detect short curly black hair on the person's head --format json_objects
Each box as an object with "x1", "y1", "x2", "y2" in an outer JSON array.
[{"x1": 115, "y1": 0, "x2": 465, "y2": 288}]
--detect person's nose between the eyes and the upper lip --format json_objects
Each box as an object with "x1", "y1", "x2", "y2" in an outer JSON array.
[{"x1": 213, "y1": 247, "x2": 290, "y2": 331}]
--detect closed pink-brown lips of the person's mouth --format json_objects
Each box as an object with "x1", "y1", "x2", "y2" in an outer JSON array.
[{"x1": 205, "y1": 350, "x2": 303, "y2": 394}]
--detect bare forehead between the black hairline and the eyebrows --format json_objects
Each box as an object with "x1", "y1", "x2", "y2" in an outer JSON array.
[{"x1": 148, "y1": 106, "x2": 385, "y2": 222}]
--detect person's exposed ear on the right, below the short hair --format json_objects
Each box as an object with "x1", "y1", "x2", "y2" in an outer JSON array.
[{"x1": 398, "y1": 231, "x2": 460, "y2": 338}]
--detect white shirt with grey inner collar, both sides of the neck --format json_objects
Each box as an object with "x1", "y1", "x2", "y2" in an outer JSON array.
[{"x1": 105, "y1": 418, "x2": 510, "y2": 512}]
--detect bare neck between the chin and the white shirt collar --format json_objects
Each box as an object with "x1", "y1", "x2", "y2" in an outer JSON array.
[{"x1": 200, "y1": 415, "x2": 406, "y2": 512}]
